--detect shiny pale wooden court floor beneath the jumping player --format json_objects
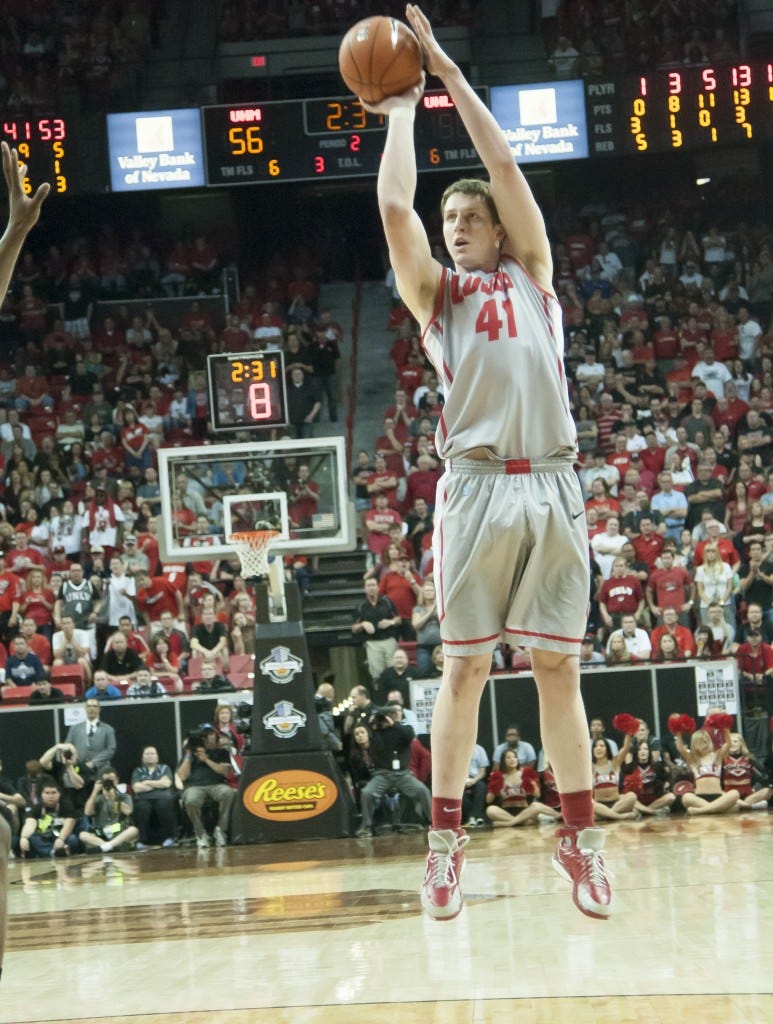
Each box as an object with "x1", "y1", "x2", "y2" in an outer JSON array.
[{"x1": 0, "y1": 812, "x2": 773, "y2": 1024}]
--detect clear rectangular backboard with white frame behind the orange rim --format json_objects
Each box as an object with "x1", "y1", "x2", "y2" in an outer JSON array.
[{"x1": 158, "y1": 437, "x2": 356, "y2": 561}]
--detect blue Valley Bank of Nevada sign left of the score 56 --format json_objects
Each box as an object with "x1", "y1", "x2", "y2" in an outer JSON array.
[{"x1": 108, "y1": 109, "x2": 204, "y2": 191}]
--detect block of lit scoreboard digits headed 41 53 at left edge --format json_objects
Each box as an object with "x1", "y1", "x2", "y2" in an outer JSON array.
[{"x1": 0, "y1": 115, "x2": 73, "y2": 196}]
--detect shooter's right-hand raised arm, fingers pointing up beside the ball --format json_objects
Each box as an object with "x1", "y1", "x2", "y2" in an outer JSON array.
[{"x1": 405, "y1": 4, "x2": 553, "y2": 289}]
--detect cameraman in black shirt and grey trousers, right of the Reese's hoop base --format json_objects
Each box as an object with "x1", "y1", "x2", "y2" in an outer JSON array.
[{"x1": 357, "y1": 708, "x2": 431, "y2": 838}]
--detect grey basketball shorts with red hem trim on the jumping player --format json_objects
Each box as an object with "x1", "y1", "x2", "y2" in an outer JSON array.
[{"x1": 433, "y1": 459, "x2": 590, "y2": 655}]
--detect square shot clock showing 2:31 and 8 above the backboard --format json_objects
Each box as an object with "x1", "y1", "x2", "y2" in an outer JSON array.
[{"x1": 207, "y1": 351, "x2": 287, "y2": 431}]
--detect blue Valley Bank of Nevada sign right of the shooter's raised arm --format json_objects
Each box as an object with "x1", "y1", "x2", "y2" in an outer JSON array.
[{"x1": 490, "y1": 81, "x2": 588, "y2": 164}]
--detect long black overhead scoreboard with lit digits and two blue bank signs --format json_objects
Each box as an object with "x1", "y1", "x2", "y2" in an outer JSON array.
[{"x1": 7, "y1": 60, "x2": 773, "y2": 196}]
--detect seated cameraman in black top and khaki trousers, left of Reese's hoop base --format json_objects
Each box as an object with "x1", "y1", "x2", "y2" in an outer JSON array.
[{"x1": 177, "y1": 724, "x2": 237, "y2": 850}]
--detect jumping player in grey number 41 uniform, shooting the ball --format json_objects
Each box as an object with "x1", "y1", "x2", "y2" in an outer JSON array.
[{"x1": 366, "y1": 4, "x2": 611, "y2": 921}]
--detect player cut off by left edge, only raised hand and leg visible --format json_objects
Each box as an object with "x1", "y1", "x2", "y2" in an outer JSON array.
[{"x1": 0, "y1": 142, "x2": 50, "y2": 977}]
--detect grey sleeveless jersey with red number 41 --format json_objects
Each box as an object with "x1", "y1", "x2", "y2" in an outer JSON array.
[{"x1": 422, "y1": 256, "x2": 576, "y2": 460}]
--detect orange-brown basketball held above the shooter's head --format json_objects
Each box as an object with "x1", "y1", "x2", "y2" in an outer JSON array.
[{"x1": 338, "y1": 15, "x2": 422, "y2": 103}]
